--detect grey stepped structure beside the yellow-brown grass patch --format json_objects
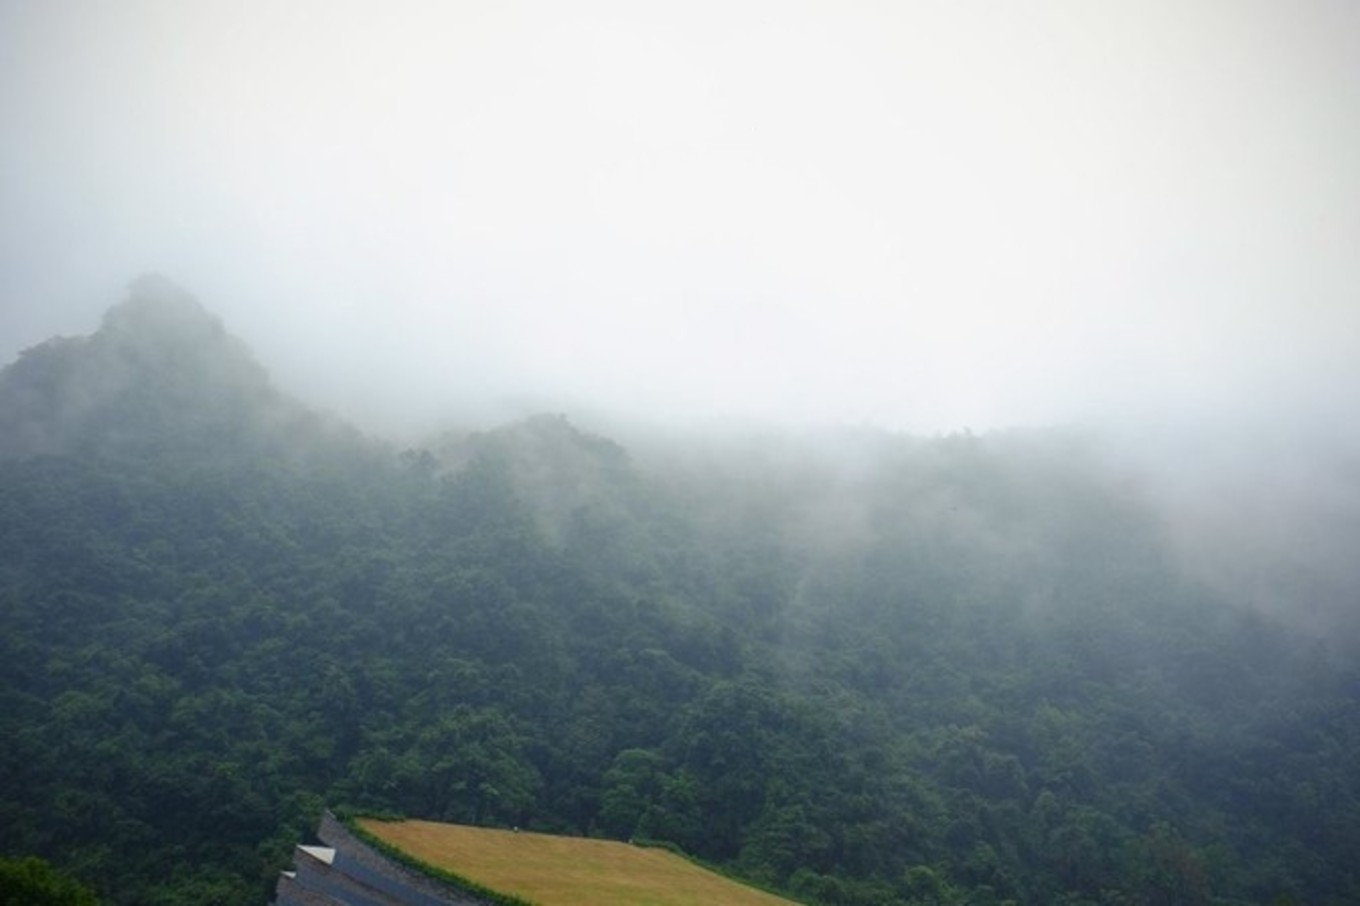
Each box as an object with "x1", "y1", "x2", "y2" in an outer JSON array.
[{"x1": 273, "y1": 812, "x2": 500, "y2": 906}]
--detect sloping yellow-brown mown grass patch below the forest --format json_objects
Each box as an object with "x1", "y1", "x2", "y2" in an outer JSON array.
[{"x1": 359, "y1": 819, "x2": 792, "y2": 906}]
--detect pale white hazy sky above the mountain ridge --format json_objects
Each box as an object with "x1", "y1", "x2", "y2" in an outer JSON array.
[{"x1": 0, "y1": 0, "x2": 1360, "y2": 431}]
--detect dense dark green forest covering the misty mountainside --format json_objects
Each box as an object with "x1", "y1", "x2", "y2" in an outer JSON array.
[{"x1": 0, "y1": 280, "x2": 1360, "y2": 906}]
